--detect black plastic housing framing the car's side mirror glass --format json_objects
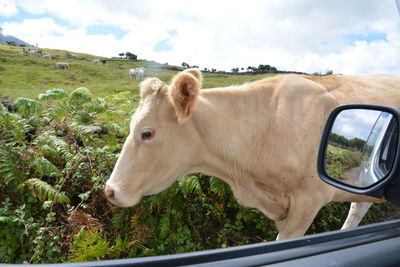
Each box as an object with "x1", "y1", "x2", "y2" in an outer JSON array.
[{"x1": 317, "y1": 104, "x2": 400, "y2": 206}]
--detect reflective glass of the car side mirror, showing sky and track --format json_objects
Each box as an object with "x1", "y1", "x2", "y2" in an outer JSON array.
[{"x1": 325, "y1": 109, "x2": 399, "y2": 188}]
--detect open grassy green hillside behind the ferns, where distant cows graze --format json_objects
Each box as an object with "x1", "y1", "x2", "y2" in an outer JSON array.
[{"x1": 0, "y1": 45, "x2": 271, "y2": 98}]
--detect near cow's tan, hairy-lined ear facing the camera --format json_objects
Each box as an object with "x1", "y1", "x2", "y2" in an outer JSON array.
[{"x1": 169, "y1": 69, "x2": 201, "y2": 123}]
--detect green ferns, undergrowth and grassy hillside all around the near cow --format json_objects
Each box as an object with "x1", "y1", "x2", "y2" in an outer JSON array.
[{"x1": 0, "y1": 47, "x2": 396, "y2": 263}]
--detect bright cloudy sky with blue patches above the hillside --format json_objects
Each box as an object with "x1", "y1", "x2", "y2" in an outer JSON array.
[{"x1": 0, "y1": 0, "x2": 400, "y2": 75}]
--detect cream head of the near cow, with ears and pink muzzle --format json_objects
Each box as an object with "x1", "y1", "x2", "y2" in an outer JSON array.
[{"x1": 105, "y1": 69, "x2": 202, "y2": 207}]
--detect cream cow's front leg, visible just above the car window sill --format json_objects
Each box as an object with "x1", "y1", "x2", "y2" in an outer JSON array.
[{"x1": 275, "y1": 196, "x2": 325, "y2": 240}]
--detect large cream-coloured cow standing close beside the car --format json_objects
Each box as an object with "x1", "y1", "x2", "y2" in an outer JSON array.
[{"x1": 105, "y1": 69, "x2": 400, "y2": 240}]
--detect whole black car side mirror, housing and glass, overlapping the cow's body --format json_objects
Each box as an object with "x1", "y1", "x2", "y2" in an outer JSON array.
[{"x1": 317, "y1": 105, "x2": 400, "y2": 206}]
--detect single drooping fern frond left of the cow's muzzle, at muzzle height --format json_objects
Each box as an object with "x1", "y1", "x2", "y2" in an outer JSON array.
[{"x1": 26, "y1": 178, "x2": 71, "y2": 203}]
